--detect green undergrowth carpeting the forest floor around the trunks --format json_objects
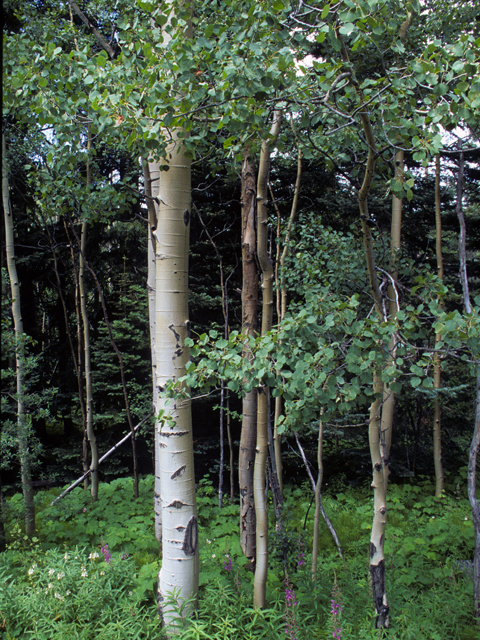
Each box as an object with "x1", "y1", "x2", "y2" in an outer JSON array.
[{"x1": 0, "y1": 477, "x2": 479, "y2": 640}]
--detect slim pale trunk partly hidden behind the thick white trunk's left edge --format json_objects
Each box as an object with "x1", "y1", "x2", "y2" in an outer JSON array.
[{"x1": 143, "y1": 160, "x2": 162, "y2": 542}]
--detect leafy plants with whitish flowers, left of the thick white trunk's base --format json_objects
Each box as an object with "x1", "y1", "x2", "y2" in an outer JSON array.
[{"x1": 0, "y1": 545, "x2": 161, "y2": 640}]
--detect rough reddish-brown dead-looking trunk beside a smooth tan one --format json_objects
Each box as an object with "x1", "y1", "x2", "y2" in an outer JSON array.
[{"x1": 238, "y1": 152, "x2": 258, "y2": 563}]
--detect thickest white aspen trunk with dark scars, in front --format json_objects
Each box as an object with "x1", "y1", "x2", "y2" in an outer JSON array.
[{"x1": 154, "y1": 131, "x2": 199, "y2": 633}]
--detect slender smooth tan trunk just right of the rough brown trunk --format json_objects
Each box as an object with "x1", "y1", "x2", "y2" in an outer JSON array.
[{"x1": 253, "y1": 111, "x2": 281, "y2": 608}]
